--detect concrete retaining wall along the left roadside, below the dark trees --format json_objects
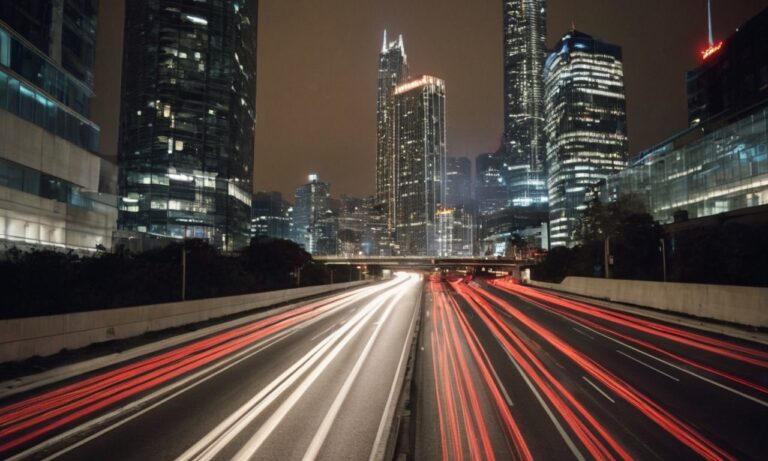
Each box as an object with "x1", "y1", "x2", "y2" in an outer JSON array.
[{"x1": 0, "y1": 281, "x2": 368, "y2": 362}]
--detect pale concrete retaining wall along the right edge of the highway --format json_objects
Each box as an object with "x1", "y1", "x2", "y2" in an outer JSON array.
[{"x1": 530, "y1": 277, "x2": 768, "y2": 328}]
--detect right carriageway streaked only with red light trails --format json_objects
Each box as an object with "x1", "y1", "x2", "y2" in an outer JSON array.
[{"x1": 414, "y1": 278, "x2": 768, "y2": 460}]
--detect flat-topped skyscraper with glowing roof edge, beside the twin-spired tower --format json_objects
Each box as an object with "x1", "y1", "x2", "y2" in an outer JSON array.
[{"x1": 394, "y1": 75, "x2": 445, "y2": 256}]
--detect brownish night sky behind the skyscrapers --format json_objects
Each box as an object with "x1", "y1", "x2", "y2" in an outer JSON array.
[{"x1": 93, "y1": 0, "x2": 768, "y2": 201}]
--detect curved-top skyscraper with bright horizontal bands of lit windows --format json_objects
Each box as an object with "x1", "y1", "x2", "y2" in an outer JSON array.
[{"x1": 544, "y1": 30, "x2": 628, "y2": 246}]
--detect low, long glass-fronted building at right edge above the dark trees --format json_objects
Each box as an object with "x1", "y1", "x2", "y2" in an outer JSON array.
[{"x1": 599, "y1": 101, "x2": 768, "y2": 223}]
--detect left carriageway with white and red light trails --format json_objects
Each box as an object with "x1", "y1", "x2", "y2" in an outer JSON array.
[{"x1": 0, "y1": 274, "x2": 423, "y2": 460}]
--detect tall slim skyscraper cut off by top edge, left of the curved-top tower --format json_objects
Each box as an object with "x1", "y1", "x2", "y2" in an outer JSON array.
[{"x1": 502, "y1": 0, "x2": 547, "y2": 207}]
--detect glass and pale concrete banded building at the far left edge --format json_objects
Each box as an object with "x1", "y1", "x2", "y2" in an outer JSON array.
[{"x1": 0, "y1": 0, "x2": 117, "y2": 252}]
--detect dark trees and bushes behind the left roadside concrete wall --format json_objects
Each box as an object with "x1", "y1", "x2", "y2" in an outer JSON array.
[{"x1": 0, "y1": 237, "x2": 358, "y2": 318}]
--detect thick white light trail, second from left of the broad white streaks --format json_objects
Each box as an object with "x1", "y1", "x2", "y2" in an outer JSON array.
[{"x1": 232, "y1": 288, "x2": 402, "y2": 461}]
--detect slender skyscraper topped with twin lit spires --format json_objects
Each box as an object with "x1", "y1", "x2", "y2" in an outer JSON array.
[{"x1": 376, "y1": 30, "x2": 408, "y2": 234}]
